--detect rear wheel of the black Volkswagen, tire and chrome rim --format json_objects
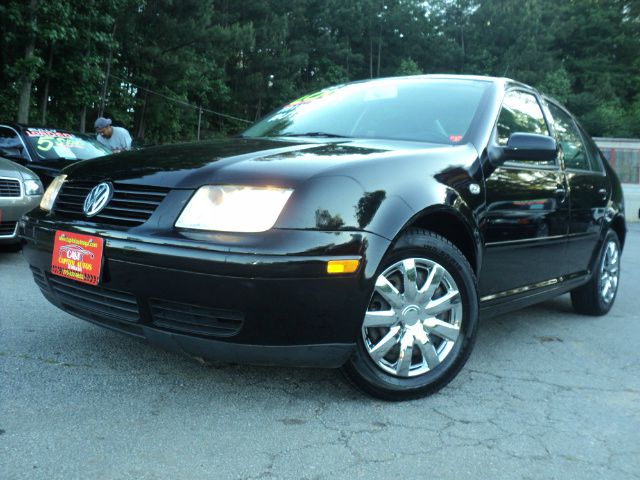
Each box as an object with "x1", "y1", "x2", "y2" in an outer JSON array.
[{"x1": 571, "y1": 230, "x2": 620, "y2": 315}]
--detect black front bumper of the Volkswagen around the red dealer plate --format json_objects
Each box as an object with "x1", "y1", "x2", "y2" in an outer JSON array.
[{"x1": 19, "y1": 211, "x2": 389, "y2": 367}]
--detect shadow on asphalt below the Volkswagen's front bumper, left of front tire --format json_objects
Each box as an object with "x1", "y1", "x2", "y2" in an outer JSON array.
[{"x1": 33, "y1": 314, "x2": 362, "y2": 401}]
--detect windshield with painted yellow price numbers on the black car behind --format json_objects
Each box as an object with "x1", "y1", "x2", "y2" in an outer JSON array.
[{"x1": 25, "y1": 128, "x2": 111, "y2": 160}]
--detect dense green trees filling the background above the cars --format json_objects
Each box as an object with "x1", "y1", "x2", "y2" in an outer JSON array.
[{"x1": 0, "y1": 0, "x2": 640, "y2": 143}]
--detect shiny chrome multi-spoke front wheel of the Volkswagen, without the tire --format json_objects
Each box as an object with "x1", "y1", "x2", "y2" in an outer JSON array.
[{"x1": 362, "y1": 258, "x2": 463, "y2": 378}]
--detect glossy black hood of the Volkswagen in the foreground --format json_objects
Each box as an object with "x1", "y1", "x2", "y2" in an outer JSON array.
[{"x1": 64, "y1": 138, "x2": 468, "y2": 189}]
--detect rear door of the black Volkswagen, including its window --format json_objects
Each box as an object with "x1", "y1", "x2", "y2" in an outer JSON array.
[{"x1": 546, "y1": 101, "x2": 610, "y2": 273}]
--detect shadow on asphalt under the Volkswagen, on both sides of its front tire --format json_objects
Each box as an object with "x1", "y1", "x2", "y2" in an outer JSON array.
[{"x1": 12, "y1": 296, "x2": 596, "y2": 403}]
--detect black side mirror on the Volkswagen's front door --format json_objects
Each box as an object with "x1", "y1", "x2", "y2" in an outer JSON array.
[{"x1": 489, "y1": 132, "x2": 558, "y2": 166}]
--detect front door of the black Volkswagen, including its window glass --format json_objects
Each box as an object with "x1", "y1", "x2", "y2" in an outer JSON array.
[{"x1": 479, "y1": 90, "x2": 569, "y2": 300}]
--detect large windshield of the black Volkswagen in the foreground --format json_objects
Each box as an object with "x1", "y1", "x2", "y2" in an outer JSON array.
[{"x1": 242, "y1": 78, "x2": 490, "y2": 145}]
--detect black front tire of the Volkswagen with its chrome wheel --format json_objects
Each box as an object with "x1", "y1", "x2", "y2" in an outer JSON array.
[{"x1": 343, "y1": 229, "x2": 478, "y2": 400}]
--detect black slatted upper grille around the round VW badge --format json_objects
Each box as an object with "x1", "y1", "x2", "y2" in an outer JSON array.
[{"x1": 54, "y1": 182, "x2": 169, "y2": 227}]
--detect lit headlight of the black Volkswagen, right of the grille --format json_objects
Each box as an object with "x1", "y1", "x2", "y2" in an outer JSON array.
[{"x1": 176, "y1": 185, "x2": 293, "y2": 232}]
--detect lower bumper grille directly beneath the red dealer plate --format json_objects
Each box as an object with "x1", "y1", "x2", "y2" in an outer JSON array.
[{"x1": 48, "y1": 275, "x2": 140, "y2": 322}]
